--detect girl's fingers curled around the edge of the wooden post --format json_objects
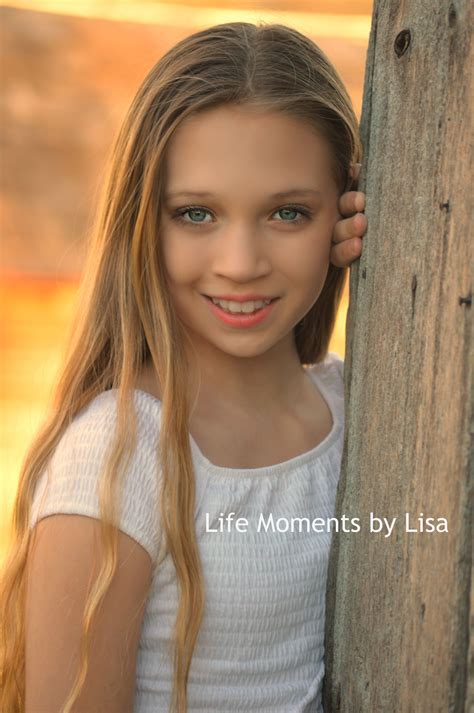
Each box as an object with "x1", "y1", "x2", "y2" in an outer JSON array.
[{"x1": 329, "y1": 163, "x2": 367, "y2": 267}]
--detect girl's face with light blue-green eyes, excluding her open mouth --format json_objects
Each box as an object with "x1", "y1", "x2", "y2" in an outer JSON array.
[{"x1": 160, "y1": 105, "x2": 340, "y2": 357}]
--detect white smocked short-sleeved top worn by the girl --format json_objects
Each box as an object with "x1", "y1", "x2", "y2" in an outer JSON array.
[{"x1": 30, "y1": 352, "x2": 344, "y2": 713}]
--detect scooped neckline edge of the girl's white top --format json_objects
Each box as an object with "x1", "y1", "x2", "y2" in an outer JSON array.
[{"x1": 123, "y1": 362, "x2": 341, "y2": 477}]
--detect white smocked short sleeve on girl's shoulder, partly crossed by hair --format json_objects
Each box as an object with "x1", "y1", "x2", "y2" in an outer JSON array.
[{"x1": 29, "y1": 391, "x2": 162, "y2": 565}]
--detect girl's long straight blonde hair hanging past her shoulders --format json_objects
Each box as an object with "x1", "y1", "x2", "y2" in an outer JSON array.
[{"x1": 0, "y1": 22, "x2": 362, "y2": 713}]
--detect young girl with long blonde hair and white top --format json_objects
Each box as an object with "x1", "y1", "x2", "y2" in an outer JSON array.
[{"x1": 1, "y1": 23, "x2": 366, "y2": 713}]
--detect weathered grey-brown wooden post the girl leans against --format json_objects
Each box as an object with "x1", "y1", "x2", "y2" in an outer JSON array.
[{"x1": 324, "y1": 0, "x2": 474, "y2": 713}]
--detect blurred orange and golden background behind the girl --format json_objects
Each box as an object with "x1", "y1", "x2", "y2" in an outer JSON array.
[{"x1": 0, "y1": 0, "x2": 372, "y2": 564}]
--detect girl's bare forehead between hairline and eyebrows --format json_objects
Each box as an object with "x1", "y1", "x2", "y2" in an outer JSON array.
[{"x1": 166, "y1": 106, "x2": 331, "y2": 192}]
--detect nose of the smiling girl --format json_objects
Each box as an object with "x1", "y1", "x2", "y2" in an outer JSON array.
[{"x1": 213, "y1": 221, "x2": 272, "y2": 284}]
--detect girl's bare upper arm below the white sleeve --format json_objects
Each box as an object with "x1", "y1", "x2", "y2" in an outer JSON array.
[{"x1": 25, "y1": 514, "x2": 152, "y2": 713}]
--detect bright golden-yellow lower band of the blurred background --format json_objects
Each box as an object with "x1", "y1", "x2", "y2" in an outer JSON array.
[{"x1": 0, "y1": 276, "x2": 348, "y2": 565}]
